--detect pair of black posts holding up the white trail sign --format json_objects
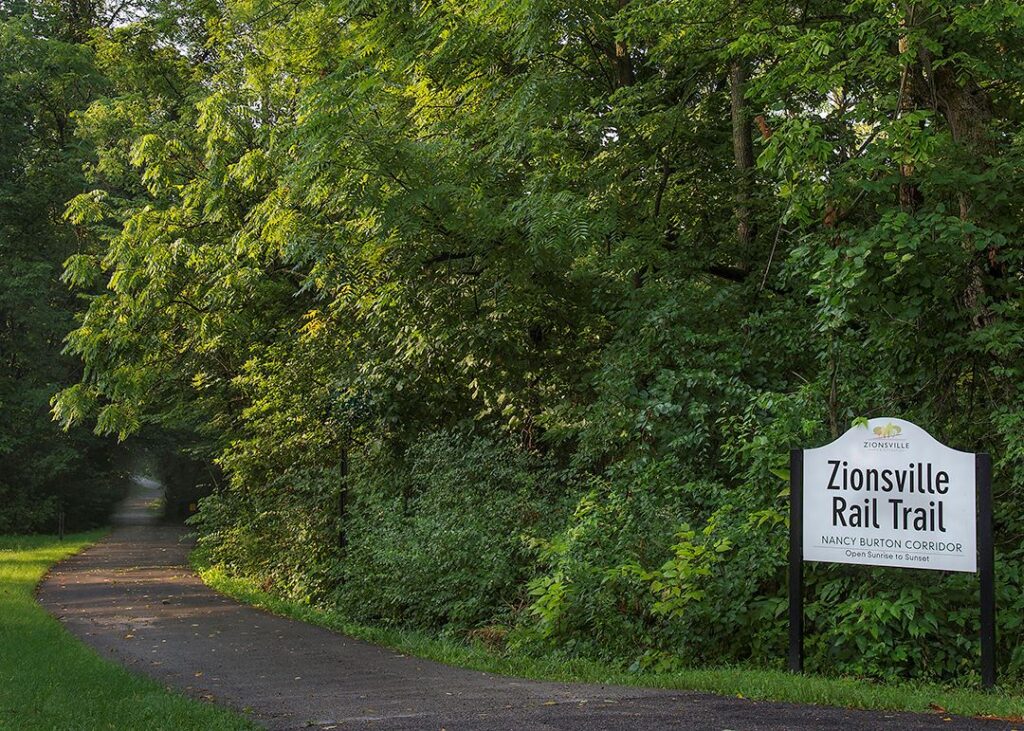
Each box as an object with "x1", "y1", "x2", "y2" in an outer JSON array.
[{"x1": 788, "y1": 449, "x2": 995, "y2": 689}]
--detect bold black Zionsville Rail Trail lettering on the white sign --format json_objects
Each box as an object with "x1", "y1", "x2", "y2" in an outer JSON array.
[{"x1": 827, "y1": 460, "x2": 949, "y2": 533}]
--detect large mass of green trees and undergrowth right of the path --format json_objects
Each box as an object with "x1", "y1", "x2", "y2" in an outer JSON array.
[{"x1": 22, "y1": 0, "x2": 1024, "y2": 679}]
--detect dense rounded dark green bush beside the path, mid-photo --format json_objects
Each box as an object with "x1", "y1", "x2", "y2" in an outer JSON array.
[{"x1": 337, "y1": 431, "x2": 564, "y2": 632}]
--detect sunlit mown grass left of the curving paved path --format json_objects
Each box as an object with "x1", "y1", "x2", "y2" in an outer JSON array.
[{"x1": 0, "y1": 532, "x2": 254, "y2": 731}]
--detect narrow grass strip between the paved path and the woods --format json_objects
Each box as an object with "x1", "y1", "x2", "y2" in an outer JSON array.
[{"x1": 198, "y1": 566, "x2": 1024, "y2": 720}]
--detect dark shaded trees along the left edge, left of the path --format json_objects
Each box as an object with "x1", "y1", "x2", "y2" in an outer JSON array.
[{"x1": 0, "y1": 3, "x2": 121, "y2": 533}]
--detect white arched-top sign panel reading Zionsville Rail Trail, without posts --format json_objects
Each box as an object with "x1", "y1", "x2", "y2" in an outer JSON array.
[{"x1": 803, "y1": 419, "x2": 978, "y2": 572}]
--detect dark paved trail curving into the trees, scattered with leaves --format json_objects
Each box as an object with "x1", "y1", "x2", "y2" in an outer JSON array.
[{"x1": 39, "y1": 484, "x2": 1008, "y2": 731}]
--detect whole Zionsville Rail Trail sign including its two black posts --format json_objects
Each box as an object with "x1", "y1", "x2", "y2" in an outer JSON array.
[{"x1": 788, "y1": 419, "x2": 995, "y2": 688}]
